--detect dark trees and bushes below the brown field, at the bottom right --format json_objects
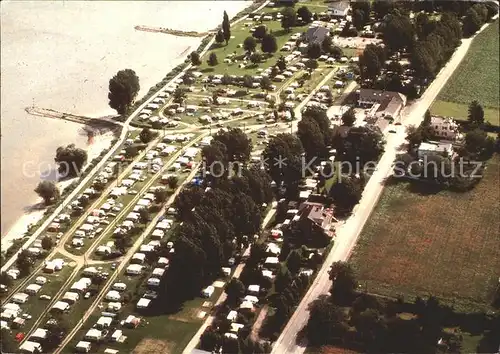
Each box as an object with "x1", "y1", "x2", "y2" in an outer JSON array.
[{"x1": 305, "y1": 262, "x2": 461, "y2": 353}]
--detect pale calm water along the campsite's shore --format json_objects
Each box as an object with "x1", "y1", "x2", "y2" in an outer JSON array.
[{"x1": 0, "y1": 1, "x2": 249, "y2": 237}]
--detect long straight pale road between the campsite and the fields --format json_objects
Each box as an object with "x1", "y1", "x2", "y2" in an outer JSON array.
[{"x1": 272, "y1": 19, "x2": 494, "y2": 354}]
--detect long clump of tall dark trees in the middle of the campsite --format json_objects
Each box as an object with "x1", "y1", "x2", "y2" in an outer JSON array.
[{"x1": 159, "y1": 129, "x2": 272, "y2": 310}]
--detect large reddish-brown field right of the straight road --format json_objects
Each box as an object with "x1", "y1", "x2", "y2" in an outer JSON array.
[{"x1": 351, "y1": 156, "x2": 500, "y2": 311}]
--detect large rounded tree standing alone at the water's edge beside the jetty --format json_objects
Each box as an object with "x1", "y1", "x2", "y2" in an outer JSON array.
[{"x1": 108, "y1": 69, "x2": 141, "y2": 114}]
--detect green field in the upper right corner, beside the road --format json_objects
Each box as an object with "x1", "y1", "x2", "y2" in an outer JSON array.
[{"x1": 431, "y1": 19, "x2": 500, "y2": 125}]
